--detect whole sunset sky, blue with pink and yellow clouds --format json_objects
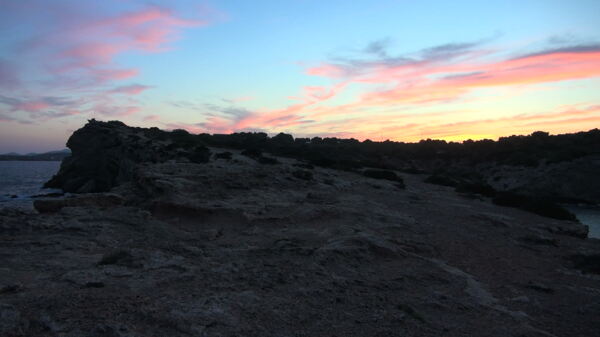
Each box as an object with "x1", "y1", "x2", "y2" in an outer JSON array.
[{"x1": 0, "y1": 0, "x2": 600, "y2": 153}]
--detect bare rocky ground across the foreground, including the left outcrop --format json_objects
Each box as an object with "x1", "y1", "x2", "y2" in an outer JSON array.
[{"x1": 0, "y1": 122, "x2": 600, "y2": 337}]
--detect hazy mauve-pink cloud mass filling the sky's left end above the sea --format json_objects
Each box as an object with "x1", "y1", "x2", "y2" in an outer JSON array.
[{"x1": 0, "y1": 1, "x2": 213, "y2": 124}]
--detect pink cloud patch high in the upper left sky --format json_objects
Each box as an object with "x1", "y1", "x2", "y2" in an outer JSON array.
[{"x1": 44, "y1": 6, "x2": 207, "y2": 81}]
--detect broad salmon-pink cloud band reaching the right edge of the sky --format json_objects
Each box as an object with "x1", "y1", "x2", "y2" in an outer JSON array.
[{"x1": 306, "y1": 47, "x2": 600, "y2": 121}]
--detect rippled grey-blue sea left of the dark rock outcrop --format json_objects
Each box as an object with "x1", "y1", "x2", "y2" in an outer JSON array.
[{"x1": 0, "y1": 161, "x2": 60, "y2": 206}]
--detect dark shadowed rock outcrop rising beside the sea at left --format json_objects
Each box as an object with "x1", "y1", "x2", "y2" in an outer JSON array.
[{"x1": 45, "y1": 119, "x2": 210, "y2": 193}]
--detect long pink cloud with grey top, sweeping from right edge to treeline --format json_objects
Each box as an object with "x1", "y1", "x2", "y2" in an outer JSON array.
[{"x1": 210, "y1": 36, "x2": 600, "y2": 139}]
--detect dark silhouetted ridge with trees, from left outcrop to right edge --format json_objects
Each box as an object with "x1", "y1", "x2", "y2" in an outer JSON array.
[{"x1": 47, "y1": 120, "x2": 600, "y2": 203}]
